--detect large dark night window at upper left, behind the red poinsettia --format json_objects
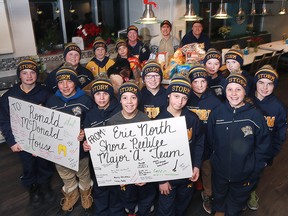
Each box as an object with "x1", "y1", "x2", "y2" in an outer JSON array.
[{"x1": 29, "y1": 0, "x2": 128, "y2": 53}]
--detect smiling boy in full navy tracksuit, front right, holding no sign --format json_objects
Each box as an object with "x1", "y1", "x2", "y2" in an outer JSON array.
[{"x1": 208, "y1": 73, "x2": 271, "y2": 216}]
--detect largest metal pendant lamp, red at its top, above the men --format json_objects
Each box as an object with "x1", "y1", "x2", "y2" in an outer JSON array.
[{"x1": 134, "y1": 0, "x2": 161, "y2": 24}]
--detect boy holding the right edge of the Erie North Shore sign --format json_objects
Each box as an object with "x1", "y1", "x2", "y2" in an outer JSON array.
[{"x1": 157, "y1": 75, "x2": 204, "y2": 216}]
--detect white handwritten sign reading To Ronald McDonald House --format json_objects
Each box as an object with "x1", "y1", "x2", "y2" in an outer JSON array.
[{"x1": 9, "y1": 97, "x2": 80, "y2": 171}]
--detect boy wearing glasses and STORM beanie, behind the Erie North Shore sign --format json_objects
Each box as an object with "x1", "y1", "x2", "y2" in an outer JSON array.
[{"x1": 140, "y1": 61, "x2": 167, "y2": 119}]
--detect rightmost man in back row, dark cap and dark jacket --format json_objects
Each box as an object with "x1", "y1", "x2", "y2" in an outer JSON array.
[{"x1": 181, "y1": 21, "x2": 211, "y2": 52}]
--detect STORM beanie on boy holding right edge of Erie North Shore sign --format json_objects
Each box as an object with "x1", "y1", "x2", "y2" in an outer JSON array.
[{"x1": 166, "y1": 74, "x2": 191, "y2": 97}]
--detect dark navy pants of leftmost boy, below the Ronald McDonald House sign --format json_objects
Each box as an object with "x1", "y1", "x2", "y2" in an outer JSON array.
[{"x1": 18, "y1": 151, "x2": 55, "y2": 188}]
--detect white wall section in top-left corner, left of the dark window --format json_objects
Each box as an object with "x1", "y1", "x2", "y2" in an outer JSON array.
[{"x1": 0, "y1": 0, "x2": 37, "y2": 58}]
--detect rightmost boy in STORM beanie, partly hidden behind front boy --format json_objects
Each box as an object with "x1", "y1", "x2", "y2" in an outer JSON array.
[{"x1": 247, "y1": 65, "x2": 287, "y2": 210}]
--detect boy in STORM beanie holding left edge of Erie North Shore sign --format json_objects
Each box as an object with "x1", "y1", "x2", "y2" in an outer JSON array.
[{"x1": 83, "y1": 77, "x2": 123, "y2": 216}]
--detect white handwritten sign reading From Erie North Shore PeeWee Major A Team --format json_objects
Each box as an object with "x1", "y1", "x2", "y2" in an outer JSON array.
[{"x1": 85, "y1": 117, "x2": 192, "y2": 186}]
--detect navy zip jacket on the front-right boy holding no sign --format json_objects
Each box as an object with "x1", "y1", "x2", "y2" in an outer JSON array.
[{"x1": 208, "y1": 101, "x2": 271, "y2": 182}]
